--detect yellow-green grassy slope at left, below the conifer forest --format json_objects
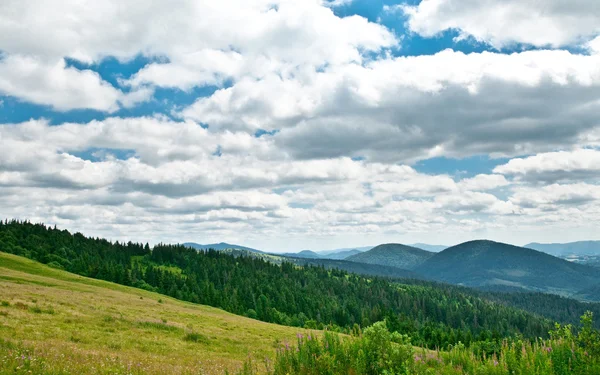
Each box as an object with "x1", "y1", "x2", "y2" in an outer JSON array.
[{"x1": 0, "y1": 252, "x2": 310, "y2": 374}]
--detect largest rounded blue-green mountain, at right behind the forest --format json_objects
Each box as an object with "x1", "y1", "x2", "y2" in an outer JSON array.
[{"x1": 415, "y1": 240, "x2": 600, "y2": 295}]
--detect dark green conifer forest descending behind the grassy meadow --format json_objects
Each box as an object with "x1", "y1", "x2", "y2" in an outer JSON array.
[{"x1": 0, "y1": 221, "x2": 552, "y2": 348}]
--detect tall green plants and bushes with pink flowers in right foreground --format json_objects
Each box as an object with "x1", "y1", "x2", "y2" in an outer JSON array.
[{"x1": 243, "y1": 313, "x2": 600, "y2": 375}]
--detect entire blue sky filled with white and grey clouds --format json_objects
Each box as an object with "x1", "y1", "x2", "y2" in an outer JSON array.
[{"x1": 0, "y1": 0, "x2": 600, "y2": 252}]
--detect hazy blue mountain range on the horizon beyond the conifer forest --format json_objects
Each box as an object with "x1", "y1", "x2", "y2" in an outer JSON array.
[{"x1": 186, "y1": 240, "x2": 600, "y2": 301}]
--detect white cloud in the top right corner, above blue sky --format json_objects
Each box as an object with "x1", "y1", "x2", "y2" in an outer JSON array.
[{"x1": 401, "y1": 0, "x2": 600, "y2": 48}]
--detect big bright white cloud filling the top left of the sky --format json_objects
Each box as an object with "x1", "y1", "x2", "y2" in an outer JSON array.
[{"x1": 0, "y1": 0, "x2": 398, "y2": 101}]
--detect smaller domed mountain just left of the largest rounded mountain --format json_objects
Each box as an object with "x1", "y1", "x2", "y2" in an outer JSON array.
[{"x1": 346, "y1": 243, "x2": 434, "y2": 270}]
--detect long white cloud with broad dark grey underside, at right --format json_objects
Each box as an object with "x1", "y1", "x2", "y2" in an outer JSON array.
[{"x1": 181, "y1": 50, "x2": 600, "y2": 162}]
